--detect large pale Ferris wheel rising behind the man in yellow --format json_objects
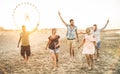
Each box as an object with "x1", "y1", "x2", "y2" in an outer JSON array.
[{"x1": 13, "y1": 2, "x2": 40, "y2": 31}]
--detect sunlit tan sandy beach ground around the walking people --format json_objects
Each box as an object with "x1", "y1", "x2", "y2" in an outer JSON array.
[{"x1": 0, "y1": 29, "x2": 120, "y2": 74}]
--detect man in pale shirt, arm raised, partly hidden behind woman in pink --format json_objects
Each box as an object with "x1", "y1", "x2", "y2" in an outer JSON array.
[{"x1": 93, "y1": 19, "x2": 109, "y2": 61}]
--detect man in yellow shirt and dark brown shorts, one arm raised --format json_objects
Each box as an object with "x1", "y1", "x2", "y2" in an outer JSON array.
[{"x1": 17, "y1": 24, "x2": 39, "y2": 63}]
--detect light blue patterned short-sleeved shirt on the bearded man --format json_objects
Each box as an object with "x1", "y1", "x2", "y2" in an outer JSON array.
[{"x1": 66, "y1": 25, "x2": 77, "y2": 39}]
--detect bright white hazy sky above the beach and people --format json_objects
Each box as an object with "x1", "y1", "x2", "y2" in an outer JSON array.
[{"x1": 0, "y1": 0, "x2": 120, "y2": 29}]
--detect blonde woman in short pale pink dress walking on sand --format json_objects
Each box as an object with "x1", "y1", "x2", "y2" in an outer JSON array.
[{"x1": 78, "y1": 28, "x2": 96, "y2": 70}]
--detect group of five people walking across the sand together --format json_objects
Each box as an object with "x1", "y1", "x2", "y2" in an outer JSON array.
[{"x1": 18, "y1": 12, "x2": 109, "y2": 69}]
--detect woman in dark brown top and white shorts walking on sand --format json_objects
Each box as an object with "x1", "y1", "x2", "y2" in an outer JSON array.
[{"x1": 45, "y1": 28, "x2": 60, "y2": 68}]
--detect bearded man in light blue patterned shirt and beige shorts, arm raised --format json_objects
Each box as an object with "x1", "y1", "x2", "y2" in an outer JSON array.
[{"x1": 58, "y1": 12, "x2": 79, "y2": 60}]
